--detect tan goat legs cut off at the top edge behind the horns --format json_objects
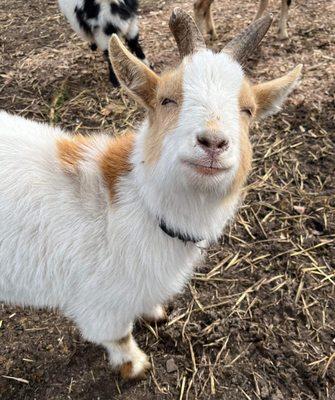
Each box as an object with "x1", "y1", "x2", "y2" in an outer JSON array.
[{"x1": 193, "y1": 0, "x2": 292, "y2": 40}]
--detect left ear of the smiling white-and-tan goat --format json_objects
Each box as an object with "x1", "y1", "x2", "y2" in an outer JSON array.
[{"x1": 109, "y1": 34, "x2": 159, "y2": 108}]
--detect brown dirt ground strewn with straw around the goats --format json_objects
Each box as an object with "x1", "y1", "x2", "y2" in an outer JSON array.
[{"x1": 0, "y1": 0, "x2": 335, "y2": 400}]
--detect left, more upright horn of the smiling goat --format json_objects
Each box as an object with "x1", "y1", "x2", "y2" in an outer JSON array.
[{"x1": 169, "y1": 7, "x2": 206, "y2": 58}]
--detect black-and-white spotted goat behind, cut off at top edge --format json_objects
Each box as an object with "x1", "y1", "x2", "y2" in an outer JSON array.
[{"x1": 58, "y1": 0, "x2": 149, "y2": 87}]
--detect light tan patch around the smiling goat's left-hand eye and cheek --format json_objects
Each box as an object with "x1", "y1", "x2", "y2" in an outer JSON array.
[{"x1": 144, "y1": 65, "x2": 183, "y2": 165}]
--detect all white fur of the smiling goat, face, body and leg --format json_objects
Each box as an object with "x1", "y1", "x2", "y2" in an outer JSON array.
[{"x1": 0, "y1": 43, "x2": 300, "y2": 376}]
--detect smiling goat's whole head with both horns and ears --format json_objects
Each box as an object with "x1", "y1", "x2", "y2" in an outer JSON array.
[{"x1": 109, "y1": 9, "x2": 301, "y2": 194}]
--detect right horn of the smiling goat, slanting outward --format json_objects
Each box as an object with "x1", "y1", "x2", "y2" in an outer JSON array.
[{"x1": 222, "y1": 14, "x2": 273, "y2": 64}]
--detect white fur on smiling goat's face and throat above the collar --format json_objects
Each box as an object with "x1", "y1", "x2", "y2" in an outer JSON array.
[{"x1": 134, "y1": 50, "x2": 243, "y2": 242}]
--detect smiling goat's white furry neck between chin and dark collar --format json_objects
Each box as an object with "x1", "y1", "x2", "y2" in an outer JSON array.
[{"x1": 132, "y1": 123, "x2": 240, "y2": 241}]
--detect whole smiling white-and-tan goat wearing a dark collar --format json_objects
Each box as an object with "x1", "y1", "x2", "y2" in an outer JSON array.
[{"x1": 0, "y1": 8, "x2": 301, "y2": 378}]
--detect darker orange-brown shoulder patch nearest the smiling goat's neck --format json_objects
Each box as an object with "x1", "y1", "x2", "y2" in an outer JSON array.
[{"x1": 100, "y1": 132, "x2": 135, "y2": 198}]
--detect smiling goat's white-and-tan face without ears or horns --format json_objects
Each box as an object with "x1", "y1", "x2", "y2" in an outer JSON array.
[{"x1": 143, "y1": 50, "x2": 252, "y2": 191}]
